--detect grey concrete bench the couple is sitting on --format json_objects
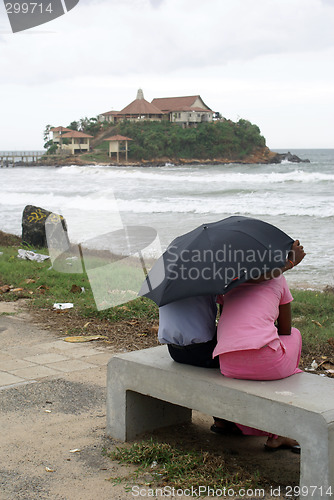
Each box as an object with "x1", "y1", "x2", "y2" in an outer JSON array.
[{"x1": 107, "y1": 346, "x2": 334, "y2": 500}]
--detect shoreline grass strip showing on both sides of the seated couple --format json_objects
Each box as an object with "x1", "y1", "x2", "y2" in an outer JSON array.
[{"x1": 0, "y1": 242, "x2": 334, "y2": 346}]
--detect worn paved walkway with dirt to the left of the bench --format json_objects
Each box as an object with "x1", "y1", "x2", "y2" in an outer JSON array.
[{"x1": 0, "y1": 302, "x2": 132, "y2": 500}]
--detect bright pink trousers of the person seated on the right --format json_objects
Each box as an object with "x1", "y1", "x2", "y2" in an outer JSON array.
[{"x1": 219, "y1": 328, "x2": 302, "y2": 436}]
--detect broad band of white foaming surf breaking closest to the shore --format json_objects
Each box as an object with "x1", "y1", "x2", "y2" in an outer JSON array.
[{"x1": 0, "y1": 189, "x2": 334, "y2": 218}]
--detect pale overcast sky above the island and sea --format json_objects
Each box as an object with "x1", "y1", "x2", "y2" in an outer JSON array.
[{"x1": 0, "y1": 0, "x2": 334, "y2": 150}]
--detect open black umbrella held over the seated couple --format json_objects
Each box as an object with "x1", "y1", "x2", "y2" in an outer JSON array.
[{"x1": 139, "y1": 216, "x2": 293, "y2": 306}]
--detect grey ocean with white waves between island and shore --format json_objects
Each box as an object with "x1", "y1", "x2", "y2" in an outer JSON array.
[{"x1": 0, "y1": 149, "x2": 334, "y2": 289}]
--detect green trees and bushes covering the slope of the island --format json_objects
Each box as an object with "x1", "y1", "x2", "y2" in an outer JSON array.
[{"x1": 44, "y1": 114, "x2": 266, "y2": 161}]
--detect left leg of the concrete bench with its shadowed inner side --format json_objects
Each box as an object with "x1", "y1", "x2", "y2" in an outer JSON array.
[{"x1": 107, "y1": 387, "x2": 192, "y2": 441}]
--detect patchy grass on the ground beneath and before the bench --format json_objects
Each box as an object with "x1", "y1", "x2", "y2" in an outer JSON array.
[{"x1": 108, "y1": 438, "x2": 258, "y2": 490}]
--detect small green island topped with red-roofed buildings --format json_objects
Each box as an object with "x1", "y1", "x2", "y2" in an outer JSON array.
[{"x1": 43, "y1": 89, "x2": 310, "y2": 165}]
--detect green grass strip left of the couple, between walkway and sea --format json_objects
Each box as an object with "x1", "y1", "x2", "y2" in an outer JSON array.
[{"x1": 0, "y1": 247, "x2": 158, "y2": 322}]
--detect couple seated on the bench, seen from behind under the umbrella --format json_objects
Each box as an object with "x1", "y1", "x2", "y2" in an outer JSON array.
[{"x1": 158, "y1": 240, "x2": 305, "y2": 453}]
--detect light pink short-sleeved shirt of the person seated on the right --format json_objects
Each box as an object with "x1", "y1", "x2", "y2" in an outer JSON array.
[{"x1": 213, "y1": 275, "x2": 293, "y2": 357}]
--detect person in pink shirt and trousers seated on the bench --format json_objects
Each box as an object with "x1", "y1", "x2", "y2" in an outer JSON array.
[{"x1": 212, "y1": 240, "x2": 305, "y2": 451}]
